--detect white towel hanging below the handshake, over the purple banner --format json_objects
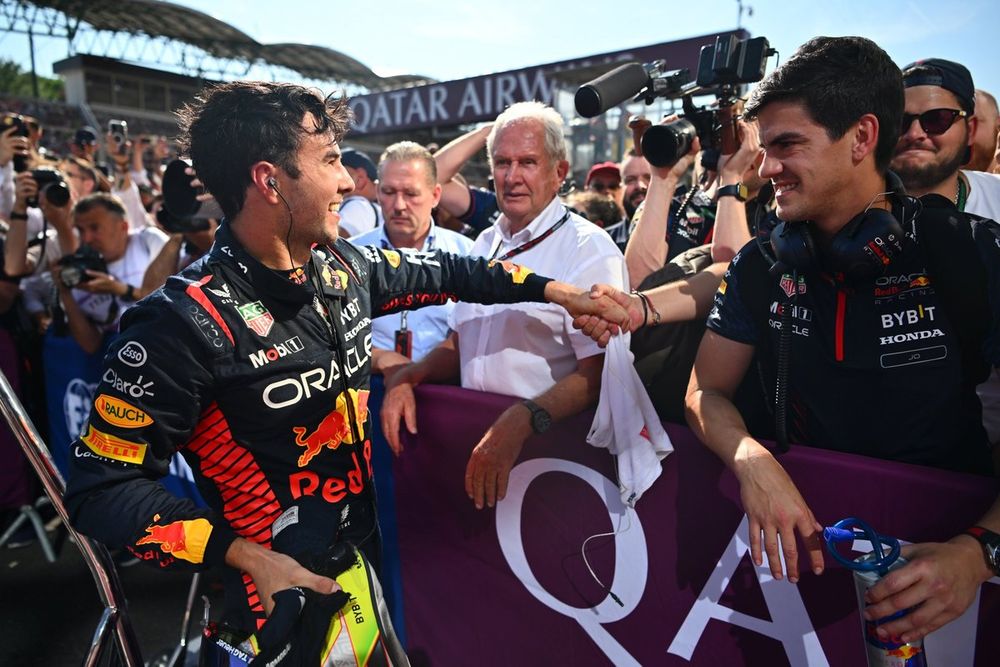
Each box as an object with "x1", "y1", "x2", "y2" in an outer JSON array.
[{"x1": 587, "y1": 333, "x2": 674, "y2": 508}]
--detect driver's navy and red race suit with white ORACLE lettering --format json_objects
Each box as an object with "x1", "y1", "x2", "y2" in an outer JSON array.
[{"x1": 66, "y1": 224, "x2": 548, "y2": 630}]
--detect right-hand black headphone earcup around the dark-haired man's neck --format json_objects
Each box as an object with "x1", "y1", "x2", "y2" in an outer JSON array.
[{"x1": 824, "y1": 208, "x2": 905, "y2": 280}]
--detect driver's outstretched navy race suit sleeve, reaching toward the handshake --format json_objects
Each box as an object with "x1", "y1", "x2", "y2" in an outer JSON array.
[{"x1": 350, "y1": 246, "x2": 551, "y2": 316}]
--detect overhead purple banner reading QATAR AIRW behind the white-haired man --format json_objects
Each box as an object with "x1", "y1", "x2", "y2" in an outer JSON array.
[{"x1": 350, "y1": 30, "x2": 748, "y2": 135}]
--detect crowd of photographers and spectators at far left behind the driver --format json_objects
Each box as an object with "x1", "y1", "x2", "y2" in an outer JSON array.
[{"x1": 0, "y1": 103, "x2": 214, "y2": 543}]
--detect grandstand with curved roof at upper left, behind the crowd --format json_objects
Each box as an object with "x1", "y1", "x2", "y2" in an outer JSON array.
[{"x1": 0, "y1": 0, "x2": 433, "y2": 152}]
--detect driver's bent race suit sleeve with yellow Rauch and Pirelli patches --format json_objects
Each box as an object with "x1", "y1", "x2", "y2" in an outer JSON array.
[{"x1": 65, "y1": 295, "x2": 235, "y2": 569}]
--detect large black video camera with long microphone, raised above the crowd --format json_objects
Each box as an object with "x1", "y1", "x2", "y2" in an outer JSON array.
[{"x1": 575, "y1": 35, "x2": 776, "y2": 167}]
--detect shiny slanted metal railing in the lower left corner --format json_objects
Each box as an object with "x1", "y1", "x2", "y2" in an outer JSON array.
[{"x1": 0, "y1": 372, "x2": 143, "y2": 667}]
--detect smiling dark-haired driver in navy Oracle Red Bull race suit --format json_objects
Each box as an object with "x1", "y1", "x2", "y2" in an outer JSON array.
[{"x1": 66, "y1": 82, "x2": 627, "y2": 631}]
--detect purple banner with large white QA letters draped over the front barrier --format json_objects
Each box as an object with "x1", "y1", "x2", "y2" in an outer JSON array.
[{"x1": 394, "y1": 387, "x2": 1000, "y2": 667}]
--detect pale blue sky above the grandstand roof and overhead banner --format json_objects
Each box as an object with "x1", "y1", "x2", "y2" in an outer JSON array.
[{"x1": 0, "y1": 0, "x2": 1000, "y2": 97}]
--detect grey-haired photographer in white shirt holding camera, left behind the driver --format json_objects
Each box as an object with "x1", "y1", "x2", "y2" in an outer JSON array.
[{"x1": 53, "y1": 193, "x2": 167, "y2": 354}]
